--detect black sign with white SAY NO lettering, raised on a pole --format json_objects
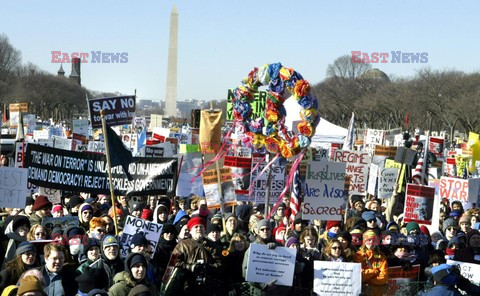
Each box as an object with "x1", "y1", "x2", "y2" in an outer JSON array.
[{"x1": 88, "y1": 96, "x2": 135, "y2": 128}]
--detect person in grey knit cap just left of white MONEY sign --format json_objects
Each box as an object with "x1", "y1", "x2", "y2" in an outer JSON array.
[{"x1": 92, "y1": 235, "x2": 124, "y2": 286}]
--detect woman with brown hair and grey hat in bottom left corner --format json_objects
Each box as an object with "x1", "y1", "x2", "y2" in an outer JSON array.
[{"x1": 0, "y1": 241, "x2": 39, "y2": 290}]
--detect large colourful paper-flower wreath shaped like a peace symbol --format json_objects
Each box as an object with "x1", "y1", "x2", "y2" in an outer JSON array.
[{"x1": 232, "y1": 63, "x2": 320, "y2": 159}]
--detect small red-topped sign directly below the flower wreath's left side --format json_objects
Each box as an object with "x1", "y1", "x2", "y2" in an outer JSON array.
[{"x1": 223, "y1": 156, "x2": 252, "y2": 194}]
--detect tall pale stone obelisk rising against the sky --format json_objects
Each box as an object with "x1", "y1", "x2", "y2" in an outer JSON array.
[{"x1": 165, "y1": 6, "x2": 178, "y2": 117}]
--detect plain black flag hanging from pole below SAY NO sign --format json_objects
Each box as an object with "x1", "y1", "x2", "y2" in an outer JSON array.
[{"x1": 107, "y1": 124, "x2": 133, "y2": 181}]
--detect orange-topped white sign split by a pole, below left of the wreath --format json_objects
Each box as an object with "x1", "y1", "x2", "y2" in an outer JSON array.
[{"x1": 202, "y1": 168, "x2": 236, "y2": 207}]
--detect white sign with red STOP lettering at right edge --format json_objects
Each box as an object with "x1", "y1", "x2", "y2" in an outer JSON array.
[{"x1": 439, "y1": 177, "x2": 480, "y2": 203}]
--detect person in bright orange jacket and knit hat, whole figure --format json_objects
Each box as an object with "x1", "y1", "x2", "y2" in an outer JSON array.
[{"x1": 353, "y1": 230, "x2": 388, "y2": 295}]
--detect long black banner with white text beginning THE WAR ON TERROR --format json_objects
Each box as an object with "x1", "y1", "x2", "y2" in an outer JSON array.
[{"x1": 25, "y1": 144, "x2": 178, "y2": 195}]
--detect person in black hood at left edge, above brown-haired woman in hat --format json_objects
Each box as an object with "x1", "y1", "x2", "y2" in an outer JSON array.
[{"x1": 2, "y1": 215, "x2": 30, "y2": 267}]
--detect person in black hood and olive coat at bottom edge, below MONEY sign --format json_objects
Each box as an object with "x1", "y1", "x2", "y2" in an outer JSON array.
[{"x1": 108, "y1": 253, "x2": 157, "y2": 296}]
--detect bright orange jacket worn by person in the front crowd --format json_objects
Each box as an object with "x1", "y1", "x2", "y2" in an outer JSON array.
[{"x1": 353, "y1": 249, "x2": 388, "y2": 286}]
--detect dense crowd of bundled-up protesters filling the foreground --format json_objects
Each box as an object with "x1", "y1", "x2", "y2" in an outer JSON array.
[{"x1": 0, "y1": 188, "x2": 480, "y2": 296}]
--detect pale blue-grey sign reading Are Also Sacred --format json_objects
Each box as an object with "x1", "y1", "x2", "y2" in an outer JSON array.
[{"x1": 302, "y1": 161, "x2": 348, "y2": 221}]
